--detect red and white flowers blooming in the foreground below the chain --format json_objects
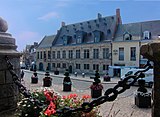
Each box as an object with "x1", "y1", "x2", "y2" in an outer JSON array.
[{"x1": 17, "y1": 89, "x2": 101, "y2": 117}]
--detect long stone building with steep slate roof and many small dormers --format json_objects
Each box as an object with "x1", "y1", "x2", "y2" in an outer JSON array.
[{"x1": 37, "y1": 9, "x2": 121, "y2": 74}]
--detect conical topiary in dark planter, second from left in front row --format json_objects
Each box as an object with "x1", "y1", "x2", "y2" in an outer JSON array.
[{"x1": 43, "y1": 67, "x2": 52, "y2": 87}]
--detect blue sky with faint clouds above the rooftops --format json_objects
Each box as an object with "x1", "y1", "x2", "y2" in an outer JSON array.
[{"x1": 0, "y1": 0, "x2": 160, "y2": 51}]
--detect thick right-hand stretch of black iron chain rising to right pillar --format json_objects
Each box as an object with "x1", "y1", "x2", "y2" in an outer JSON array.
[{"x1": 57, "y1": 61, "x2": 151, "y2": 117}]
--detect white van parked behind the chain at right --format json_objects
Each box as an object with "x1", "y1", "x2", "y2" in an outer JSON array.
[{"x1": 120, "y1": 69, "x2": 154, "y2": 87}]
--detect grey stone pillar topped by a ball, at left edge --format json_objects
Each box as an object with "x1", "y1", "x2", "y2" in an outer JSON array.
[{"x1": 0, "y1": 17, "x2": 20, "y2": 112}]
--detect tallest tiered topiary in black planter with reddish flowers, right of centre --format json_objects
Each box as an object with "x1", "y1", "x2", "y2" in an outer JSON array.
[{"x1": 90, "y1": 70, "x2": 103, "y2": 98}]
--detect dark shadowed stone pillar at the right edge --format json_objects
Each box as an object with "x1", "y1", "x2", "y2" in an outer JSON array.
[{"x1": 140, "y1": 42, "x2": 160, "y2": 117}]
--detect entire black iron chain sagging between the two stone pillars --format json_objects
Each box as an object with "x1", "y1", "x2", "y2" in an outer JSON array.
[{"x1": 5, "y1": 56, "x2": 151, "y2": 117}]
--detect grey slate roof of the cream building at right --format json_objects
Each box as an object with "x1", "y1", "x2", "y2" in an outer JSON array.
[{"x1": 114, "y1": 20, "x2": 160, "y2": 41}]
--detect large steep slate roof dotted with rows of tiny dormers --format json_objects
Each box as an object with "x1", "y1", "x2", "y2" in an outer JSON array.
[{"x1": 53, "y1": 15, "x2": 116, "y2": 46}]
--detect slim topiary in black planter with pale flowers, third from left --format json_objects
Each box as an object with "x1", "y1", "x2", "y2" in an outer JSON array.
[{"x1": 63, "y1": 69, "x2": 72, "y2": 91}]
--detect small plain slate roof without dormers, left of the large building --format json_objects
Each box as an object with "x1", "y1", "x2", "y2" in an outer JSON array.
[{"x1": 37, "y1": 35, "x2": 56, "y2": 49}]
